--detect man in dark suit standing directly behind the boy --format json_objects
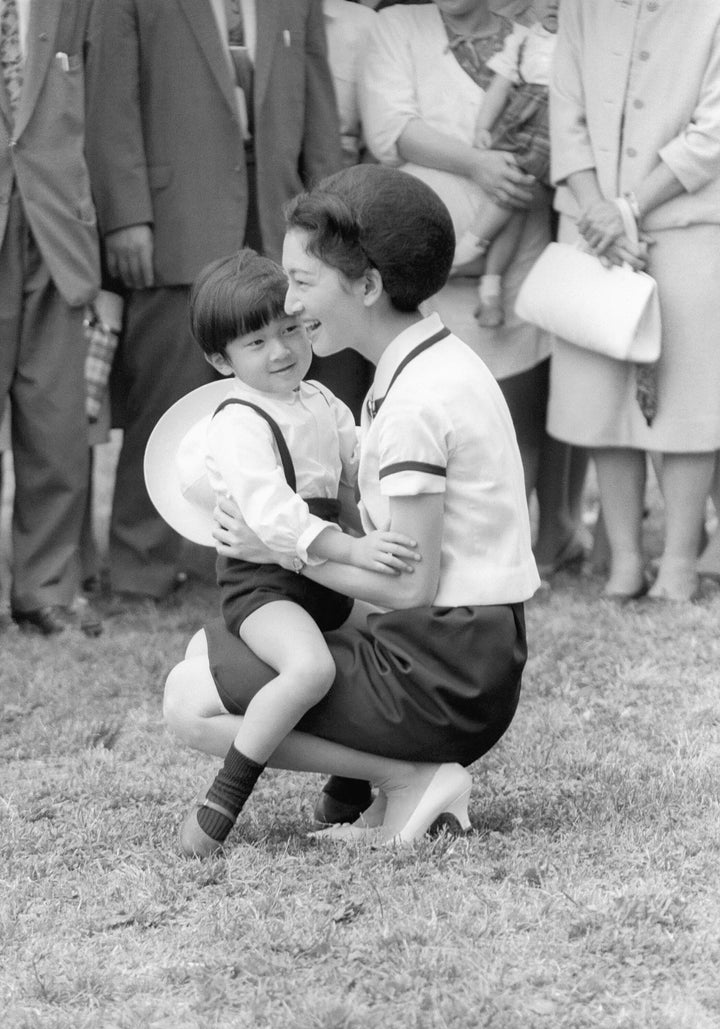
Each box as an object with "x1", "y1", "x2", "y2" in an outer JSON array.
[{"x1": 87, "y1": 0, "x2": 341, "y2": 598}]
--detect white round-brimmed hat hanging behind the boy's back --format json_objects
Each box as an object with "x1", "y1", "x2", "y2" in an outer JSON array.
[{"x1": 144, "y1": 378, "x2": 233, "y2": 546}]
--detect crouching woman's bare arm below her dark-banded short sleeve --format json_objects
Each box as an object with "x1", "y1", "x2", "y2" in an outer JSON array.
[{"x1": 302, "y1": 493, "x2": 444, "y2": 609}]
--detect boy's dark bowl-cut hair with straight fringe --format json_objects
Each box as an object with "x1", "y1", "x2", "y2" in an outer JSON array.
[{"x1": 190, "y1": 249, "x2": 288, "y2": 356}]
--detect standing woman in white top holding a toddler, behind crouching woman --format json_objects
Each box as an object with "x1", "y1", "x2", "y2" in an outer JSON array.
[{"x1": 361, "y1": 0, "x2": 584, "y2": 577}]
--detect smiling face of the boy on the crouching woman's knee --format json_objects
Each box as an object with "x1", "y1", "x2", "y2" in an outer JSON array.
[{"x1": 209, "y1": 315, "x2": 313, "y2": 393}]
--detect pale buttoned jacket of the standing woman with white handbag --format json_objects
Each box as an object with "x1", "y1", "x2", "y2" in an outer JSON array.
[{"x1": 550, "y1": 0, "x2": 720, "y2": 228}]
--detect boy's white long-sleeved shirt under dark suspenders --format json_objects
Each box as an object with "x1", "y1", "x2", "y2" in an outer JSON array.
[{"x1": 207, "y1": 379, "x2": 359, "y2": 565}]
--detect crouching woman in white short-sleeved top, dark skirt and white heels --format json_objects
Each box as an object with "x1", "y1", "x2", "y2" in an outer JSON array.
[{"x1": 166, "y1": 165, "x2": 539, "y2": 842}]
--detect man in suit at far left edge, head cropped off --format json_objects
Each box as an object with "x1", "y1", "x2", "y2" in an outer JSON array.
[{"x1": 0, "y1": 0, "x2": 100, "y2": 634}]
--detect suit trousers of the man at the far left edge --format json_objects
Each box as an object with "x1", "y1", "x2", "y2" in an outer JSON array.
[{"x1": 0, "y1": 190, "x2": 88, "y2": 611}]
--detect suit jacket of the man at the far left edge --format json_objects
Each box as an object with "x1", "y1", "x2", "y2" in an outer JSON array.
[{"x1": 0, "y1": 0, "x2": 100, "y2": 307}]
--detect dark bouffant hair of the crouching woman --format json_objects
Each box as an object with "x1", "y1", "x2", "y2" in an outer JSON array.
[{"x1": 285, "y1": 165, "x2": 455, "y2": 312}]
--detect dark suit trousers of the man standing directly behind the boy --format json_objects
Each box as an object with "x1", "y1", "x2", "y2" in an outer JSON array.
[{"x1": 109, "y1": 286, "x2": 217, "y2": 599}]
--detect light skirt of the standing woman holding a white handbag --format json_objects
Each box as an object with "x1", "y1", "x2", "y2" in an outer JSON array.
[{"x1": 547, "y1": 217, "x2": 720, "y2": 454}]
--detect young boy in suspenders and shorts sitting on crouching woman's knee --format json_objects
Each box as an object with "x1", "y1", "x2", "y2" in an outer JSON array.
[{"x1": 180, "y1": 250, "x2": 417, "y2": 856}]
